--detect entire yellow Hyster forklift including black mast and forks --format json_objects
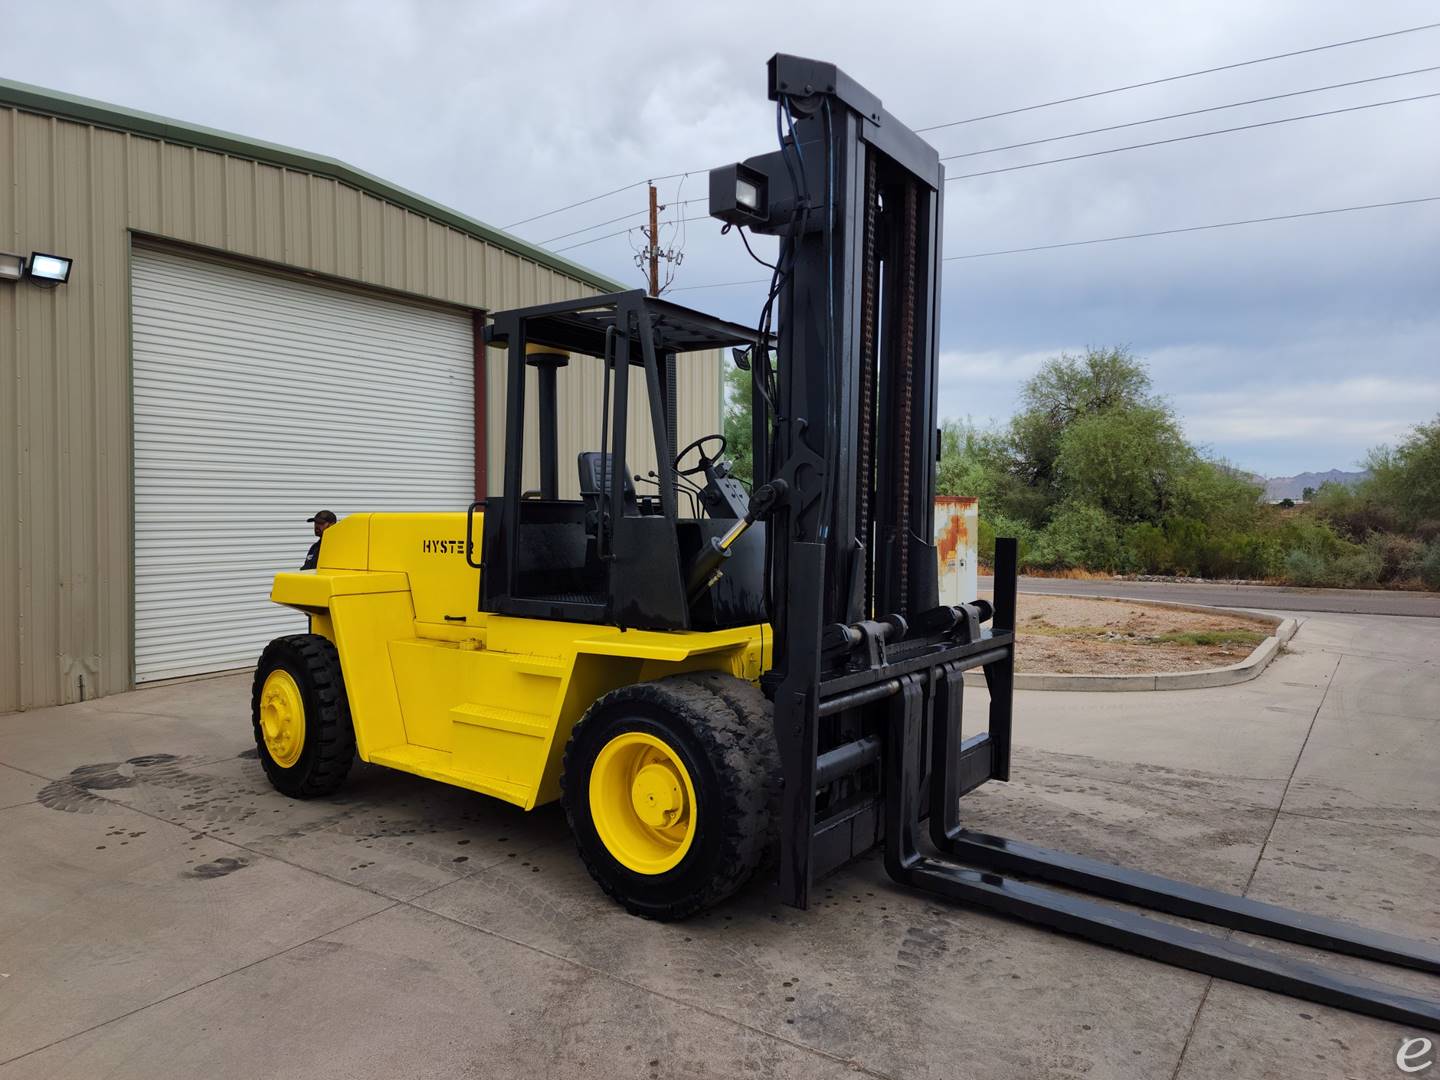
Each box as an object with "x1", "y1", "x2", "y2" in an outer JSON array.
[{"x1": 253, "y1": 55, "x2": 1440, "y2": 1030}]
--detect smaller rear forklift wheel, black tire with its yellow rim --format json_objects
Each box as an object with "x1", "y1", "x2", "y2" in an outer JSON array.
[{"x1": 251, "y1": 634, "x2": 356, "y2": 799}]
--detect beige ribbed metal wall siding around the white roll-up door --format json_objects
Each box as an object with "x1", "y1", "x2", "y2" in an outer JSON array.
[{"x1": 0, "y1": 105, "x2": 720, "y2": 711}]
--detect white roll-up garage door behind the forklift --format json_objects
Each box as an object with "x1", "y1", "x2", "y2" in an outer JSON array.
[{"x1": 132, "y1": 249, "x2": 475, "y2": 683}]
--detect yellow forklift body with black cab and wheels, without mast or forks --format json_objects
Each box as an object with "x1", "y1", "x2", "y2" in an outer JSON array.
[{"x1": 255, "y1": 292, "x2": 783, "y2": 919}]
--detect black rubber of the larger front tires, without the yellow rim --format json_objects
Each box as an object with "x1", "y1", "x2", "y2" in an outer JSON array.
[{"x1": 560, "y1": 671, "x2": 779, "y2": 922}]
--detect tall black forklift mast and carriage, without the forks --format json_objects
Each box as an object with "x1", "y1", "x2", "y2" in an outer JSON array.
[{"x1": 710, "y1": 55, "x2": 1014, "y2": 907}]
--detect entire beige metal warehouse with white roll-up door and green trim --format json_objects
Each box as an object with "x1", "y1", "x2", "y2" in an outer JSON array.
[{"x1": 0, "y1": 81, "x2": 721, "y2": 711}]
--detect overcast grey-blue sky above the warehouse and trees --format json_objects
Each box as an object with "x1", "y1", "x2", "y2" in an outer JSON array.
[{"x1": 0, "y1": 0, "x2": 1440, "y2": 475}]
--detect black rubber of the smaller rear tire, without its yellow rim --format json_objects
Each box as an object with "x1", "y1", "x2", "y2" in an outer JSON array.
[{"x1": 251, "y1": 634, "x2": 356, "y2": 799}]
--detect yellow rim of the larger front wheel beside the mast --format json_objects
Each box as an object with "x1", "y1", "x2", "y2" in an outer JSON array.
[{"x1": 590, "y1": 732, "x2": 696, "y2": 874}]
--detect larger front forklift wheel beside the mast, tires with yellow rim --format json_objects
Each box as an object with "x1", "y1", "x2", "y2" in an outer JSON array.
[{"x1": 560, "y1": 671, "x2": 779, "y2": 920}]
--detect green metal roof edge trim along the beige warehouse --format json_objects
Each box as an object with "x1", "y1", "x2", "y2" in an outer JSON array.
[{"x1": 0, "y1": 79, "x2": 626, "y2": 292}]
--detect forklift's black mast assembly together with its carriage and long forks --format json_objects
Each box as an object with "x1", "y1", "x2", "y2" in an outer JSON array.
[{"x1": 710, "y1": 55, "x2": 1440, "y2": 1030}]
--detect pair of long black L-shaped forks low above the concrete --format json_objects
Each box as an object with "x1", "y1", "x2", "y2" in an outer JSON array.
[{"x1": 884, "y1": 648, "x2": 1440, "y2": 1031}]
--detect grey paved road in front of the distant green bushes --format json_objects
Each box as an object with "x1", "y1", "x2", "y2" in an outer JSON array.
[{"x1": 981, "y1": 577, "x2": 1440, "y2": 619}]
